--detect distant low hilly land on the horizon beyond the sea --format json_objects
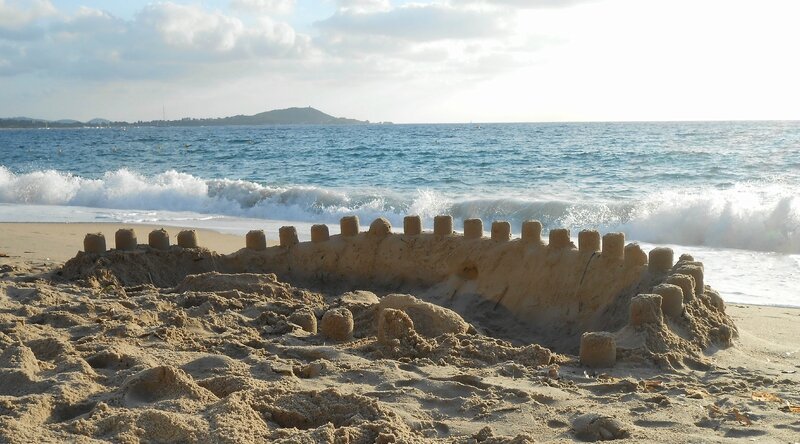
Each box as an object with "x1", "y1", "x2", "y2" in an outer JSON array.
[{"x1": 0, "y1": 106, "x2": 376, "y2": 128}]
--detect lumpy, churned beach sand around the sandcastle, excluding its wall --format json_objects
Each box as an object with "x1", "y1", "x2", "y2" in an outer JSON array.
[{"x1": 0, "y1": 224, "x2": 800, "y2": 443}]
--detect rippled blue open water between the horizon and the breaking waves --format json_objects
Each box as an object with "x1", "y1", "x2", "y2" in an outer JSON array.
[{"x1": 6, "y1": 122, "x2": 800, "y2": 201}]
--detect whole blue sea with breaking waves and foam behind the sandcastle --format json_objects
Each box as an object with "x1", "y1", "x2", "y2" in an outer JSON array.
[{"x1": 0, "y1": 121, "x2": 800, "y2": 307}]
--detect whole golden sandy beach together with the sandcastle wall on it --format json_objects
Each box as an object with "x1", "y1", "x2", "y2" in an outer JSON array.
[{"x1": 0, "y1": 221, "x2": 800, "y2": 443}]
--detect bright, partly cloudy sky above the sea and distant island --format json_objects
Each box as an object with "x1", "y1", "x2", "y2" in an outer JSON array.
[{"x1": 0, "y1": 0, "x2": 800, "y2": 123}]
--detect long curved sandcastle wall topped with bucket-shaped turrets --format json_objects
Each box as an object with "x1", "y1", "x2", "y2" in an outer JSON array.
[{"x1": 72, "y1": 216, "x2": 736, "y2": 367}]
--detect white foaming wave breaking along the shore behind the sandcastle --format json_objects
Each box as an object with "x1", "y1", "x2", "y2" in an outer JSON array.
[{"x1": 0, "y1": 166, "x2": 800, "y2": 254}]
